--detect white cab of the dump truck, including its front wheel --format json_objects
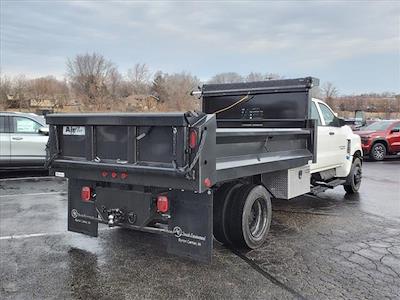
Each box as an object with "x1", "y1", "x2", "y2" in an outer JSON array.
[{"x1": 310, "y1": 98, "x2": 362, "y2": 193}]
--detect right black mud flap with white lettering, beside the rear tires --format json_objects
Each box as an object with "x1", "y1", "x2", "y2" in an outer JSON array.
[{"x1": 167, "y1": 191, "x2": 213, "y2": 262}]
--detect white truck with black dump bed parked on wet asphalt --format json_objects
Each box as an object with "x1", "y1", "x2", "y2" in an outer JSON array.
[{"x1": 46, "y1": 77, "x2": 362, "y2": 261}]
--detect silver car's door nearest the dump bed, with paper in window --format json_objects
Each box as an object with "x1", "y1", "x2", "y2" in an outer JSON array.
[{"x1": 10, "y1": 116, "x2": 48, "y2": 165}]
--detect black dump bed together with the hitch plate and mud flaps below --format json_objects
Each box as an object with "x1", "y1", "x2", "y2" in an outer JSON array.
[{"x1": 46, "y1": 77, "x2": 318, "y2": 261}]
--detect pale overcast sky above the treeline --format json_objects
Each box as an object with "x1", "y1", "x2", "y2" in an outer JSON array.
[{"x1": 0, "y1": 0, "x2": 400, "y2": 93}]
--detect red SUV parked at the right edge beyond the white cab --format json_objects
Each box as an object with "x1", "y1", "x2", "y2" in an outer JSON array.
[{"x1": 354, "y1": 120, "x2": 400, "y2": 160}]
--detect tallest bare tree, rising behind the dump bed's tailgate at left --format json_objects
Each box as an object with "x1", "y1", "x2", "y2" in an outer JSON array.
[{"x1": 67, "y1": 53, "x2": 118, "y2": 104}]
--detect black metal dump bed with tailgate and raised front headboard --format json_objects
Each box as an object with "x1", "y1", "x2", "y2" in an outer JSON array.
[{"x1": 46, "y1": 78, "x2": 317, "y2": 192}]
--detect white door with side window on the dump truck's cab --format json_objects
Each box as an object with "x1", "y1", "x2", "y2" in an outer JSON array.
[{"x1": 317, "y1": 102, "x2": 347, "y2": 169}]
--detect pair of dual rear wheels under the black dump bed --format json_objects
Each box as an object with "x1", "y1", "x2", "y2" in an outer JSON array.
[{"x1": 213, "y1": 183, "x2": 272, "y2": 249}]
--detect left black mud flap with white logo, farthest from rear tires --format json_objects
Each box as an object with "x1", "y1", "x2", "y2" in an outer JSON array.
[{"x1": 68, "y1": 179, "x2": 98, "y2": 237}]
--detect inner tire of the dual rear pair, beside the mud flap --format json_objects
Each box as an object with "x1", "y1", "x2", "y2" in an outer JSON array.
[{"x1": 213, "y1": 182, "x2": 243, "y2": 244}]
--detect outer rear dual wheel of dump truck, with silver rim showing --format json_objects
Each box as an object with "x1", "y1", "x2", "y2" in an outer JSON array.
[{"x1": 228, "y1": 185, "x2": 272, "y2": 249}]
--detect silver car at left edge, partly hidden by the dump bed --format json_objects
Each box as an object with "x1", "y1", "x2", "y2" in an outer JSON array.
[{"x1": 0, "y1": 112, "x2": 49, "y2": 169}]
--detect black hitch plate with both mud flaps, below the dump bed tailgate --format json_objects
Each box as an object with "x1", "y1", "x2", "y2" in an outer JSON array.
[{"x1": 68, "y1": 177, "x2": 213, "y2": 262}]
